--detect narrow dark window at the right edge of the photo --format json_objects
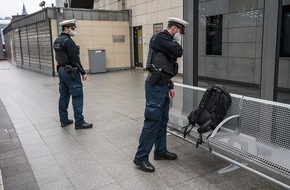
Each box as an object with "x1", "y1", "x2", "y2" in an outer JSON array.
[{"x1": 280, "y1": 5, "x2": 290, "y2": 57}]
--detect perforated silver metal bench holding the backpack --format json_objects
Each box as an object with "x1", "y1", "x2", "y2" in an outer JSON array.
[{"x1": 168, "y1": 84, "x2": 290, "y2": 189}]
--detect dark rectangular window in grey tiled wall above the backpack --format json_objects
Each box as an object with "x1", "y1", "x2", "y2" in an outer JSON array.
[{"x1": 206, "y1": 15, "x2": 223, "y2": 55}]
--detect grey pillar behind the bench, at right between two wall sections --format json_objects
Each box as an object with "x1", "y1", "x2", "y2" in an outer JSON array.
[{"x1": 260, "y1": 0, "x2": 282, "y2": 100}]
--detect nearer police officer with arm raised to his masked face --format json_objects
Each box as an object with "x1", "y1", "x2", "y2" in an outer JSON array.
[{"x1": 133, "y1": 17, "x2": 188, "y2": 172}]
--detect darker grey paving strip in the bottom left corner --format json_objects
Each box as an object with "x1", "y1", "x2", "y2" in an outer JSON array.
[{"x1": 0, "y1": 100, "x2": 39, "y2": 190}]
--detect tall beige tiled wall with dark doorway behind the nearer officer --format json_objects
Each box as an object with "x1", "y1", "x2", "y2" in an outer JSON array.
[{"x1": 94, "y1": 0, "x2": 183, "y2": 71}]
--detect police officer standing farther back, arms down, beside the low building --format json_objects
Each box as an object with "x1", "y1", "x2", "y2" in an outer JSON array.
[{"x1": 54, "y1": 19, "x2": 93, "y2": 129}]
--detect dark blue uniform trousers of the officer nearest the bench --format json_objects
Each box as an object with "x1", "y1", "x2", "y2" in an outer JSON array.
[{"x1": 135, "y1": 76, "x2": 170, "y2": 161}]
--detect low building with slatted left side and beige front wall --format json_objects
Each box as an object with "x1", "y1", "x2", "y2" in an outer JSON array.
[{"x1": 4, "y1": 7, "x2": 131, "y2": 76}]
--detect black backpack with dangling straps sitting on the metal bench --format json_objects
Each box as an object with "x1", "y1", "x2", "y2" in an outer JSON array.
[{"x1": 182, "y1": 85, "x2": 232, "y2": 147}]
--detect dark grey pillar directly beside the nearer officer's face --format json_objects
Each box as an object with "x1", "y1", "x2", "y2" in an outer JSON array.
[{"x1": 183, "y1": 0, "x2": 198, "y2": 86}]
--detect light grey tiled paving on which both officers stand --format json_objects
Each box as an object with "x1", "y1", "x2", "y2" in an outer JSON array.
[{"x1": 0, "y1": 61, "x2": 286, "y2": 190}]
